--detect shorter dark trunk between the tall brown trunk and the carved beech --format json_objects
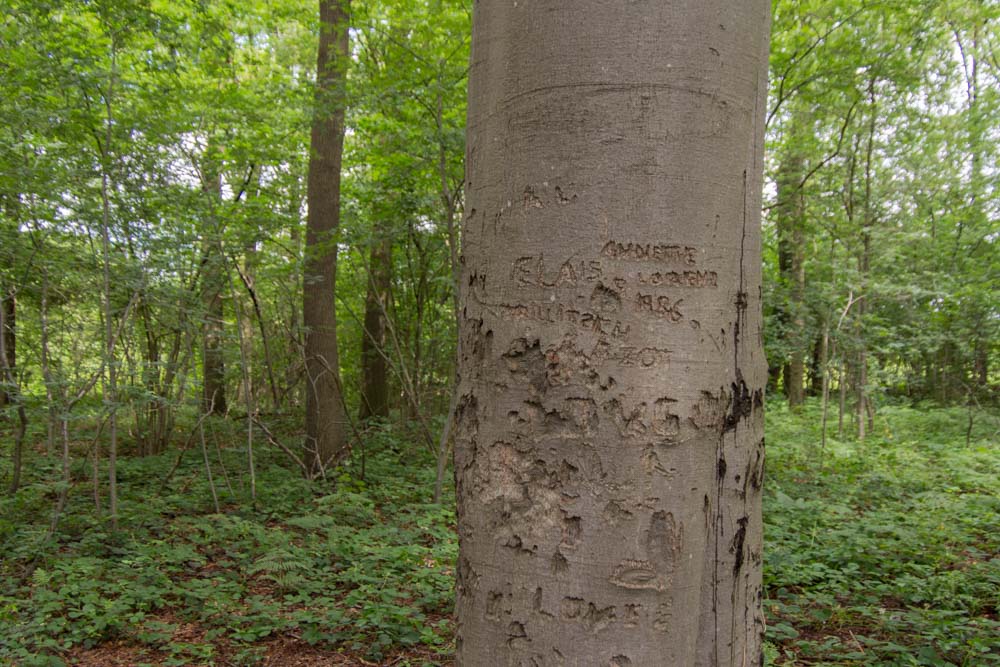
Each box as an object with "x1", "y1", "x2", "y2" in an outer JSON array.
[{"x1": 358, "y1": 231, "x2": 392, "y2": 421}]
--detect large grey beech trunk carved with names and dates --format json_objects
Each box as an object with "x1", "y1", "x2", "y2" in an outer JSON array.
[{"x1": 455, "y1": 0, "x2": 769, "y2": 667}]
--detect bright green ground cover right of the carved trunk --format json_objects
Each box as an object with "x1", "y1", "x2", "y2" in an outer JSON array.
[{"x1": 764, "y1": 404, "x2": 1000, "y2": 667}]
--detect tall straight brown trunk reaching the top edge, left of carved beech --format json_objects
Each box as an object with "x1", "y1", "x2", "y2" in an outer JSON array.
[{"x1": 302, "y1": 0, "x2": 350, "y2": 474}]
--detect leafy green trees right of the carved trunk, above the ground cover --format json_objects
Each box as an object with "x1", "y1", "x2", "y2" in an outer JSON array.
[{"x1": 764, "y1": 0, "x2": 1000, "y2": 404}]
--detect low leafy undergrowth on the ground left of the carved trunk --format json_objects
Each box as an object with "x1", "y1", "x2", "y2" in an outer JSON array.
[{"x1": 0, "y1": 426, "x2": 457, "y2": 665}]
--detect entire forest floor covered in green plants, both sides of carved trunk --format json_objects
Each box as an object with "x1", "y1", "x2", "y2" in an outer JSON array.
[{"x1": 0, "y1": 404, "x2": 1000, "y2": 667}]
